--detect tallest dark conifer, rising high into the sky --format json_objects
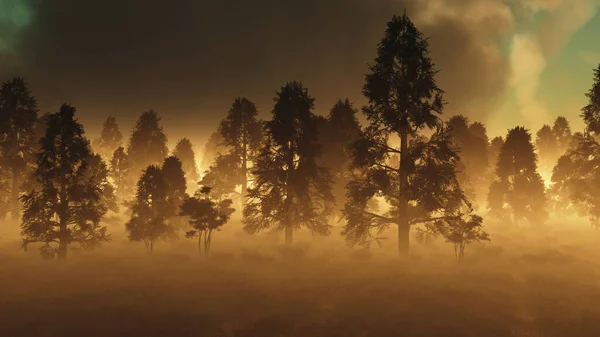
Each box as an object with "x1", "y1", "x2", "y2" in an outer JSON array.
[{"x1": 343, "y1": 13, "x2": 464, "y2": 254}]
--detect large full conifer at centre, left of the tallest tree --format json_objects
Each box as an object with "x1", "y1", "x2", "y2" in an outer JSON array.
[{"x1": 244, "y1": 82, "x2": 334, "y2": 244}]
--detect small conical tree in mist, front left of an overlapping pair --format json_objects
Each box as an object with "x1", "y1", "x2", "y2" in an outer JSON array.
[{"x1": 125, "y1": 165, "x2": 175, "y2": 253}]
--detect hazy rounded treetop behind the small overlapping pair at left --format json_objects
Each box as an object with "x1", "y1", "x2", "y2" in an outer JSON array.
[{"x1": 127, "y1": 110, "x2": 169, "y2": 177}]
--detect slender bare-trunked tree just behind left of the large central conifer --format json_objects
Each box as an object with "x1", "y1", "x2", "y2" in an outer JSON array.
[{"x1": 219, "y1": 97, "x2": 262, "y2": 204}]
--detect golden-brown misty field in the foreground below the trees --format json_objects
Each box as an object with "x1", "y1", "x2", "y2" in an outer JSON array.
[{"x1": 0, "y1": 219, "x2": 600, "y2": 336}]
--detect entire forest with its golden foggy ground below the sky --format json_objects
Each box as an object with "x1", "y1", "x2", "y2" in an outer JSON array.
[{"x1": 0, "y1": 13, "x2": 600, "y2": 336}]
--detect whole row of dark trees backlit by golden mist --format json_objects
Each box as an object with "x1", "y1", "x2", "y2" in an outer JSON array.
[{"x1": 0, "y1": 14, "x2": 600, "y2": 260}]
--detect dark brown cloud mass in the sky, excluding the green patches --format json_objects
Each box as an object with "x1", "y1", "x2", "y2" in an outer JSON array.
[{"x1": 0, "y1": 0, "x2": 507, "y2": 153}]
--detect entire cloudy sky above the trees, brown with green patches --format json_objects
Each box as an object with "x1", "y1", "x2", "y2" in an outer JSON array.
[{"x1": 0, "y1": 0, "x2": 600, "y2": 158}]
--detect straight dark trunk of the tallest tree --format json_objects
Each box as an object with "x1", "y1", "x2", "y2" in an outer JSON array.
[{"x1": 398, "y1": 131, "x2": 410, "y2": 255}]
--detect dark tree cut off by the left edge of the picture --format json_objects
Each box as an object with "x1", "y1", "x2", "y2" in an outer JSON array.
[{"x1": 0, "y1": 77, "x2": 38, "y2": 219}]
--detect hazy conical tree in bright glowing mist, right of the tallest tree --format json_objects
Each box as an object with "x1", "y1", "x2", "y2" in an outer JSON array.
[{"x1": 488, "y1": 127, "x2": 547, "y2": 222}]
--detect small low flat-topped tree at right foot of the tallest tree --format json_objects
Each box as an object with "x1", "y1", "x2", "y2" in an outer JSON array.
[{"x1": 418, "y1": 214, "x2": 490, "y2": 262}]
